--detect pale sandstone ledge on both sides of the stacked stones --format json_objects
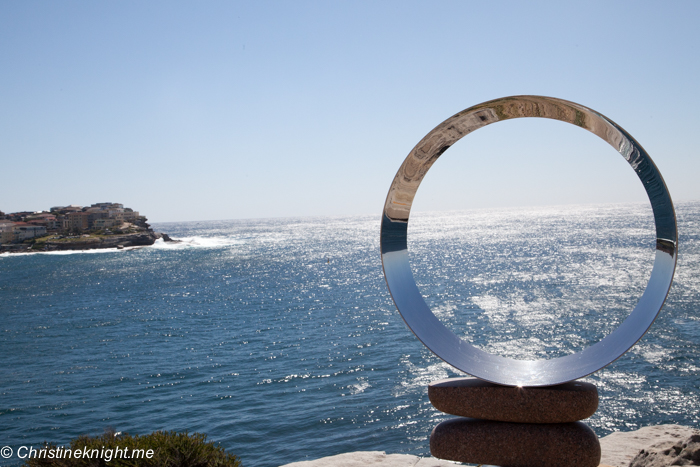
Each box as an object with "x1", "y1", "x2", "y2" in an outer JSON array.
[{"x1": 281, "y1": 425, "x2": 700, "y2": 467}]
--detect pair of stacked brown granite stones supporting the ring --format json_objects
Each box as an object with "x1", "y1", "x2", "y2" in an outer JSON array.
[{"x1": 428, "y1": 378, "x2": 600, "y2": 467}]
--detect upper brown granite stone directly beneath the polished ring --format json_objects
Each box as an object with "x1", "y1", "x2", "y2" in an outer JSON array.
[{"x1": 428, "y1": 378, "x2": 598, "y2": 423}]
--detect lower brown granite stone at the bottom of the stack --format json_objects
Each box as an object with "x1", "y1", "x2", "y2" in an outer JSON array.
[{"x1": 430, "y1": 418, "x2": 600, "y2": 467}]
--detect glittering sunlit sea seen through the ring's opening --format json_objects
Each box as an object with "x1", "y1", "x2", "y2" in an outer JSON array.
[{"x1": 409, "y1": 205, "x2": 656, "y2": 360}]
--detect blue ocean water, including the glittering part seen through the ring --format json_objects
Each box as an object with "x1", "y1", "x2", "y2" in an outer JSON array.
[{"x1": 0, "y1": 202, "x2": 700, "y2": 467}]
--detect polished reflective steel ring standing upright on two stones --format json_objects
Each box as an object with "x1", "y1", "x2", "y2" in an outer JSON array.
[{"x1": 381, "y1": 96, "x2": 678, "y2": 386}]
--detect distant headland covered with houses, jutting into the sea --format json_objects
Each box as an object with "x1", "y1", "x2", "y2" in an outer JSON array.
[{"x1": 0, "y1": 203, "x2": 149, "y2": 244}]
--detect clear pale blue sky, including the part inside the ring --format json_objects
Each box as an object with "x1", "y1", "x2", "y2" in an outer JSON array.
[{"x1": 0, "y1": 0, "x2": 700, "y2": 222}]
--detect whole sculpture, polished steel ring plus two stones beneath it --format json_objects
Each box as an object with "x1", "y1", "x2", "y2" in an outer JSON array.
[{"x1": 380, "y1": 96, "x2": 678, "y2": 466}]
